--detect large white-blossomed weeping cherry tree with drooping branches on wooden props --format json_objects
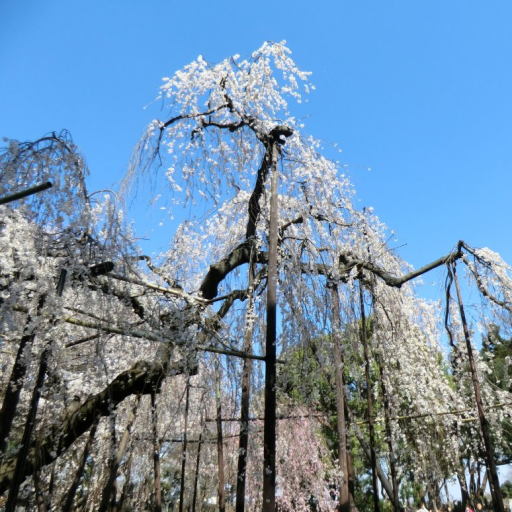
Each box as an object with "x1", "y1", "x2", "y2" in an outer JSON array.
[{"x1": 0, "y1": 43, "x2": 512, "y2": 510}]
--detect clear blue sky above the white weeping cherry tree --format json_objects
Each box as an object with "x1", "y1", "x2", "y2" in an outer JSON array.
[{"x1": 0, "y1": 0, "x2": 512, "y2": 298}]
